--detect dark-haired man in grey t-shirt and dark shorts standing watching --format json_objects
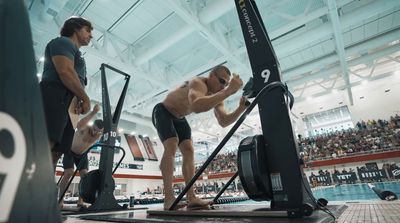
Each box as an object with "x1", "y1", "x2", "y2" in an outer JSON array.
[{"x1": 40, "y1": 16, "x2": 93, "y2": 166}]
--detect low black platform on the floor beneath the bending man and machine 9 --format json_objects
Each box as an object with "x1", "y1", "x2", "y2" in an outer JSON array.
[{"x1": 80, "y1": 205, "x2": 347, "y2": 223}]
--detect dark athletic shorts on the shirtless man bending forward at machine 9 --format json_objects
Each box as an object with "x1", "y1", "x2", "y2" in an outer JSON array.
[{"x1": 152, "y1": 103, "x2": 192, "y2": 144}]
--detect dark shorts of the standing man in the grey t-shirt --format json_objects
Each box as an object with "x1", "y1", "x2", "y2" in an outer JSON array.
[{"x1": 40, "y1": 81, "x2": 74, "y2": 153}]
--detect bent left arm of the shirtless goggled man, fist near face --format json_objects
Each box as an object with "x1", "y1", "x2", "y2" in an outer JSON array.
[{"x1": 189, "y1": 78, "x2": 231, "y2": 113}]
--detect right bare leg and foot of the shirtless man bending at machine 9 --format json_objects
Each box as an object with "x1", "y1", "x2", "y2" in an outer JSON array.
[{"x1": 179, "y1": 139, "x2": 211, "y2": 207}]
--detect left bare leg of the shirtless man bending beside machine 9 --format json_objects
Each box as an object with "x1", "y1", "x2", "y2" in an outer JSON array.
[{"x1": 160, "y1": 137, "x2": 178, "y2": 209}]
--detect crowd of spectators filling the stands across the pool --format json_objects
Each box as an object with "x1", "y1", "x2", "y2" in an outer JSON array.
[{"x1": 189, "y1": 115, "x2": 400, "y2": 175}]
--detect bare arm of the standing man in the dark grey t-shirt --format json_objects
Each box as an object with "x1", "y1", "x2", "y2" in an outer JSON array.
[{"x1": 51, "y1": 55, "x2": 90, "y2": 114}]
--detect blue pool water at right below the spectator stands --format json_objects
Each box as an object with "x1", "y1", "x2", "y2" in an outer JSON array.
[{"x1": 313, "y1": 181, "x2": 400, "y2": 201}]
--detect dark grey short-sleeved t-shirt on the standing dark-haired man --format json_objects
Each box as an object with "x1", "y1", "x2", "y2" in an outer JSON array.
[{"x1": 42, "y1": 36, "x2": 86, "y2": 86}]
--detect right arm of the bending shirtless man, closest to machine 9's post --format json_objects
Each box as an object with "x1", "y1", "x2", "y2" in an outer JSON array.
[{"x1": 214, "y1": 97, "x2": 247, "y2": 127}]
